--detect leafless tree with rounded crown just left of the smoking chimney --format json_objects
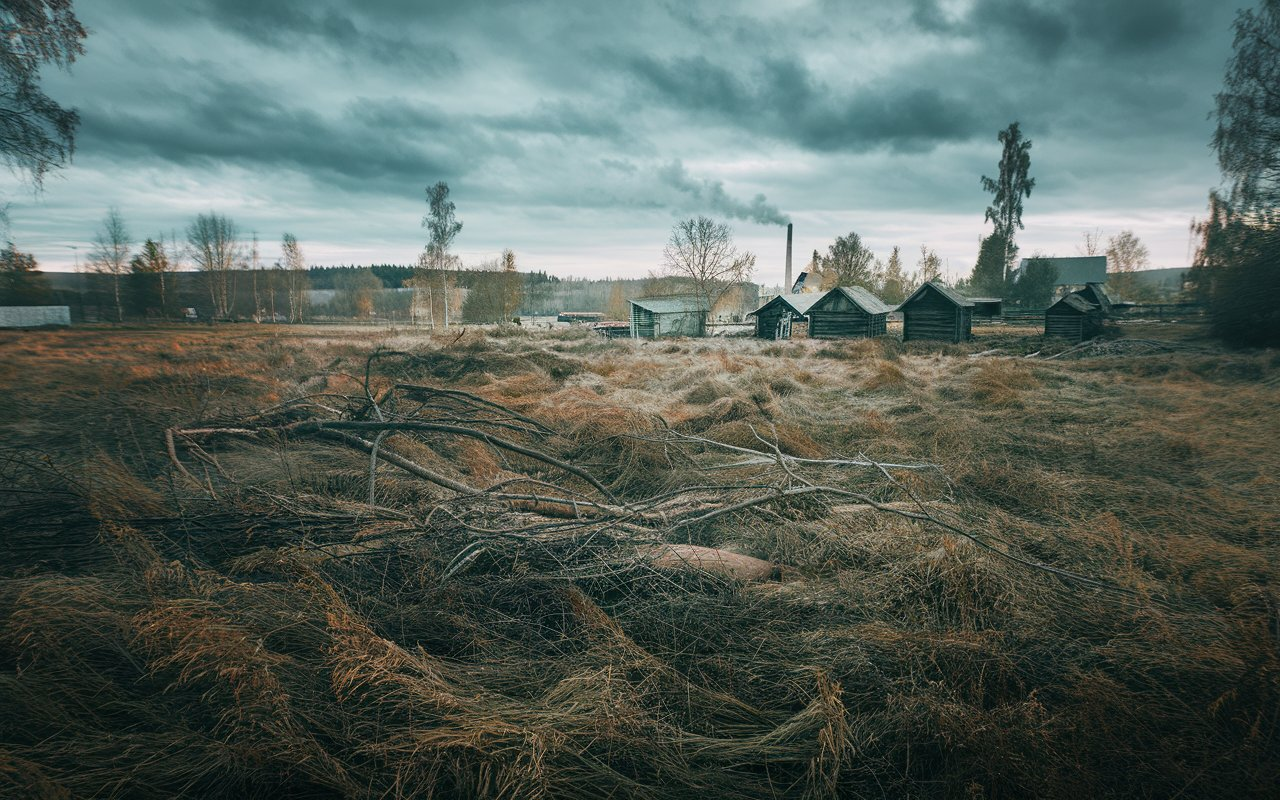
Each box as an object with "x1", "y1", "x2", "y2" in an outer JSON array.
[{"x1": 662, "y1": 216, "x2": 755, "y2": 312}]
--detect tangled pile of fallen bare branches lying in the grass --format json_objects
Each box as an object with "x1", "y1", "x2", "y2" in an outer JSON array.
[{"x1": 165, "y1": 352, "x2": 1131, "y2": 589}]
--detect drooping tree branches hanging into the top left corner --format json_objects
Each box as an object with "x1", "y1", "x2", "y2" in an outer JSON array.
[{"x1": 0, "y1": 0, "x2": 86, "y2": 187}]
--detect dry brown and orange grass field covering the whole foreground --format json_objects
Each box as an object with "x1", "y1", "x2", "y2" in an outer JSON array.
[{"x1": 0, "y1": 323, "x2": 1280, "y2": 799}]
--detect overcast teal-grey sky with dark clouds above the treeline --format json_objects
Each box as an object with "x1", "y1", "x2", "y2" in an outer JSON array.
[{"x1": 4, "y1": 0, "x2": 1248, "y2": 283}]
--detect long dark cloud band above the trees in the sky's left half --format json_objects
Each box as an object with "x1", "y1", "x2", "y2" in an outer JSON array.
[{"x1": 72, "y1": 58, "x2": 627, "y2": 191}]
